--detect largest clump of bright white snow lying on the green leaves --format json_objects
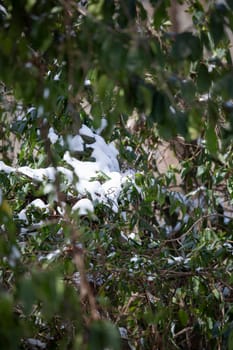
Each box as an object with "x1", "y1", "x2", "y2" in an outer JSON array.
[{"x1": 0, "y1": 125, "x2": 134, "y2": 219}]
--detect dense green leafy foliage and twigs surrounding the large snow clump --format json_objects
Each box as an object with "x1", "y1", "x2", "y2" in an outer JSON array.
[{"x1": 0, "y1": 0, "x2": 233, "y2": 350}]
